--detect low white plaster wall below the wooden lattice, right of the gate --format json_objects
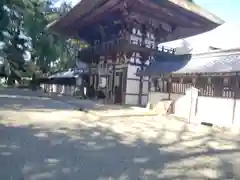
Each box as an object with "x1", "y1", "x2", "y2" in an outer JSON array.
[{"x1": 148, "y1": 92, "x2": 236, "y2": 126}]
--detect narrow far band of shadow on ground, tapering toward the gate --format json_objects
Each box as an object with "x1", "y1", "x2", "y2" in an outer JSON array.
[{"x1": 0, "y1": 88, "x2": 144, "y2": 113}]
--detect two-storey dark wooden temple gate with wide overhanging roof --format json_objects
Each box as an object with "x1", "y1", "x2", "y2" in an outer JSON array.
[{"x1": 50, "y1": 0, "x2": 223, "y2": 105}]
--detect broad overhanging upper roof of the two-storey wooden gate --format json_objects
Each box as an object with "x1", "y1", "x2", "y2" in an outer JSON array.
[{"x1": 47, "y1": 0, "x2": 224, "y2": 38}]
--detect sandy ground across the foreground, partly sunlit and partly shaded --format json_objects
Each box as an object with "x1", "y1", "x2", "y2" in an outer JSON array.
[{"x1": 0, "y1": 88, "x2": 240, "y2": 180}]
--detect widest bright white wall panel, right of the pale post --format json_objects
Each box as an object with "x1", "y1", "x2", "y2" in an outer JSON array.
[{"x1": 196, "y1": 96, "x2": 233, "y2": 126}]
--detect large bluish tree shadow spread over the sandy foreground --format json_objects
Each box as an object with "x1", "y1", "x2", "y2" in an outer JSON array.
[{"x1": 0, "y1": 117, "x2": 240, "y2": 180}]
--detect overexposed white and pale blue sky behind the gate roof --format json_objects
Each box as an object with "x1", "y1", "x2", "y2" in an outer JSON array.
[{"x1": 57, "y1": 0, "x2": 240, "y2": 53}]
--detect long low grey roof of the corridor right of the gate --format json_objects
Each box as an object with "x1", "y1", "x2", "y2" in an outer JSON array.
[{"x1": 137, "y1": 51, "x2": 240, "y2": 76}]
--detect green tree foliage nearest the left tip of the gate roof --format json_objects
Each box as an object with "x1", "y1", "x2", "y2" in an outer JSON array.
[{"x1": 25, "y1": 1, "x2": 82, "y2": 73}]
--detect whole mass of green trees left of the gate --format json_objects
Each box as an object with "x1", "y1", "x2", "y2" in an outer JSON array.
[{"x1": 0, "y1": 0, "x2": 86, "y2": 81}]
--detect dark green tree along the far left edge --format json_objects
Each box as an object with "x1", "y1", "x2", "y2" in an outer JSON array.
[{"x1": 0, "y1": 0, "x2": 27, "y2": 82}]
